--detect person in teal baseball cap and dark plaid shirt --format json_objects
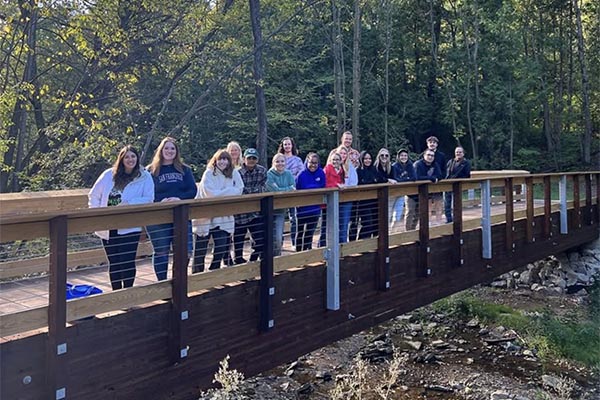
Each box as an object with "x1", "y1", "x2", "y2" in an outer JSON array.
[{"x1": 233, "y1": 147, "x2": 267, "y2": 264}]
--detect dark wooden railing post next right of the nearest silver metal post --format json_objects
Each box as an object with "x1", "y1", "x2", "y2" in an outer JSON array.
[{"x1": 375, "y1": 186, "x2": 390, "y2": 290}]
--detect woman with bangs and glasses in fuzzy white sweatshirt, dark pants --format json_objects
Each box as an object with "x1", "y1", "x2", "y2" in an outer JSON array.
[{"x1": 192, "y1": 149, "x2": 244, "y2": 273}]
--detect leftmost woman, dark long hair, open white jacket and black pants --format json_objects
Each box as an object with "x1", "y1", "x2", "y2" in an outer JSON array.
[{"x1": 88, "y1": 145, "x2": 154, "y2": 290}]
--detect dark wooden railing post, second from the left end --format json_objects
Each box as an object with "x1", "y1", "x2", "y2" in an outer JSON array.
[{"x1": 169, "y1": 204, "x2": 190, "y2": 364}]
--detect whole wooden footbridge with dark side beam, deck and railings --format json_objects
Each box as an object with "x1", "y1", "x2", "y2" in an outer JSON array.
[{"x1": 0, "y1": 172, "x2": 600, "y2": 400}]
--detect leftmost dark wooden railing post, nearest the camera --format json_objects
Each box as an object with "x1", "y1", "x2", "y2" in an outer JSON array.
[{"x1": 46, "y1": 215, "x2": 68, "y2": 400}]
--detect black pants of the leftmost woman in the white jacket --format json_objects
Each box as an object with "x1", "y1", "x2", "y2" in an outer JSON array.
[{"x1": 102, "y1": 229, "x2": 140, "y2": 290}]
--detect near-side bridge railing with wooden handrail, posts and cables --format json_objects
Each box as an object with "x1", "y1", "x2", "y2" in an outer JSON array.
[{"x1": 0, "y1": 172, "x2": 600, "y2": 341}]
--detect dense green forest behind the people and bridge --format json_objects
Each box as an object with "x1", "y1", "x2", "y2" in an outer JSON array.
[{"x1": 0, "y1": 0, "x2": 600, "y2": 192}]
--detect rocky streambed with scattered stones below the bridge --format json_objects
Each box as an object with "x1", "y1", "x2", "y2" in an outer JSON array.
[{"x1": 203, "y1": 242, "x2": 600, "y2": 400}]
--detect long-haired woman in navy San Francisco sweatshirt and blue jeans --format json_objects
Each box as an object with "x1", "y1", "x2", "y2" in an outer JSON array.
[{"x1": 146, "y1": 136, "x2": 198, "y2": 281}]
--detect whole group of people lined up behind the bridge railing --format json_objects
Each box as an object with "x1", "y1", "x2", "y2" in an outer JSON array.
[{"x1": 89, "y1": 132, "x2": 471, "y2": 290}]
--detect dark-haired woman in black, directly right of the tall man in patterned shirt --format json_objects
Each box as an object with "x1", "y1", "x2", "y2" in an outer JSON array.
[{"x1": 356, "y1": 151, "x2": 387, "y2": 239}]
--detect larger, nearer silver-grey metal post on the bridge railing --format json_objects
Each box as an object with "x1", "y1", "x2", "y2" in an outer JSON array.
[{"x1": 324, "y1": 190, "x2": 340, "y2": 311}]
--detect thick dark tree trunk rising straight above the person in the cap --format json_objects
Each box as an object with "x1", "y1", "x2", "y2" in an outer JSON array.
[{"x1": 249, "y1": 0, "x2": 269, "y2": 165}]
